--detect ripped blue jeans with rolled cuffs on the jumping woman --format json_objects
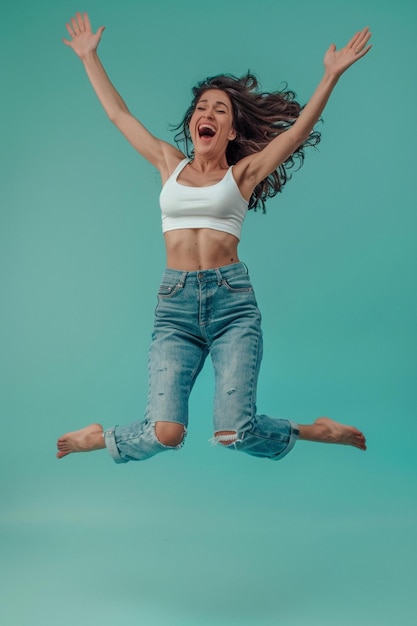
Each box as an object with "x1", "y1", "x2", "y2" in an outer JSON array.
[{"x1": 104, "y1": 263, "x2": 299, "y2": 463}]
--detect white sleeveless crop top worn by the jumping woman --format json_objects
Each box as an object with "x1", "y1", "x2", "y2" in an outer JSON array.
[{"x1": 159, "y1": 159, "x2": 248, "y2": 239}]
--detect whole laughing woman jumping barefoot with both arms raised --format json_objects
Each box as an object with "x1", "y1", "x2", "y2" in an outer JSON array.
[{"x1": 57, "y1": 13, "x2": 371, "y2": 463}]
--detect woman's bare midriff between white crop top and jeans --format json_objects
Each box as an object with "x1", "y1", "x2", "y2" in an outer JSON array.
[{"x1": 165, "y1": 228, "x2": 239, "y2": 272}]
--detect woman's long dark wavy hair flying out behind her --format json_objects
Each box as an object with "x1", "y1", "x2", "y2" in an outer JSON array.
[{"x1": 173, "y1": 72, "x2": 320, "y2": 212}]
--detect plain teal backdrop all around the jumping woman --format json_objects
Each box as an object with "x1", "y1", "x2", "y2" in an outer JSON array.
[{"x1": 0, "y1": 0, "x2": 417, "y2": 626}]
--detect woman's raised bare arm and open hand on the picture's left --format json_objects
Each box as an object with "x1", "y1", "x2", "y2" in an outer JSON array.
[{"x1": 63, "y1": 13, "x2": 184, "y2": 179}]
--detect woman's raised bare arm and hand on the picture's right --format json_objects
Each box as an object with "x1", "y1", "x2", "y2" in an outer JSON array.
[{"x1": 237, "y1": 28, "x2": 371, "y2": 197}]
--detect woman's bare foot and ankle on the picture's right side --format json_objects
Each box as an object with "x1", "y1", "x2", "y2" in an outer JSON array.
[{"x1": 299, "y1": 417, "x2": 366, "y2": 450}]
